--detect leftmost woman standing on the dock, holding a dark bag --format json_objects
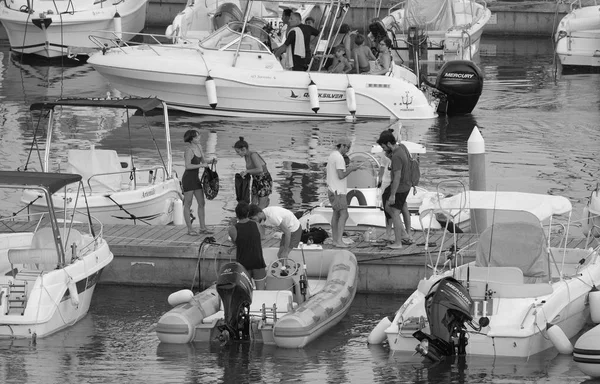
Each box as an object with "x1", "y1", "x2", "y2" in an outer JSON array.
[{"x1": 181, "y1": 129, "x2": 217, "y2": 236}]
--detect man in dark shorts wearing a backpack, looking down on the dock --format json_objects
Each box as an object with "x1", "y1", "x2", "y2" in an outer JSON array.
[{"x1": 377, "y1": 130, "x2": 412, "y2": 249}]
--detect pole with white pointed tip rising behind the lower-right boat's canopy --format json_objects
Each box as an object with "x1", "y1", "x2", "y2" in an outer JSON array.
[{"x1": 467, "y1": 126, "x2": 487, "y2": 233}]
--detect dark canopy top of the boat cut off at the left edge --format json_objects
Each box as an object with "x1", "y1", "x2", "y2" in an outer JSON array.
[{"x1": 0, "y1": 171, "x2": 81, "y2": 194}]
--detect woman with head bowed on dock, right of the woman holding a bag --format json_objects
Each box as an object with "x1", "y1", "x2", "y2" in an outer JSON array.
[{"x1": 233, "y1": 136, "x2": 273, "y2": 208}]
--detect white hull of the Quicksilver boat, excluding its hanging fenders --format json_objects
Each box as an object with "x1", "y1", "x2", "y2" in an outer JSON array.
[{"x1": 88, "y1": 45, "x2": 437, "y2": 119}]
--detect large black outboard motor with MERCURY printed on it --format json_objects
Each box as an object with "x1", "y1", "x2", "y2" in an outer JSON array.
[{"x1": 435, "y1": 60, "x2": 483, "y2": 115}]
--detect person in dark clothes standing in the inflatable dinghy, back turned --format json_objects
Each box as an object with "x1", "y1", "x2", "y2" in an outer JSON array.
[{"x1": 229, "y1": 201, "x2": 267, "y2": 289}]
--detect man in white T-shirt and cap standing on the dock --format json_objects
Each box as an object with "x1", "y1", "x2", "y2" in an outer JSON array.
[{"x1": 327, "y1": 137, "x2": 360, "y2": 248}]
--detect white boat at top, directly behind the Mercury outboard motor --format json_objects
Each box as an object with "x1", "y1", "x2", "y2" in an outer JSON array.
[{"x1": 378, "y1": 0, "x2": 492, "y2": 63}]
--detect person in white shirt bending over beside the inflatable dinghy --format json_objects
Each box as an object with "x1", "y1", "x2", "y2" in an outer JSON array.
[{"x1": 248, "y1": 204, "x2": 302, "y2": 258}]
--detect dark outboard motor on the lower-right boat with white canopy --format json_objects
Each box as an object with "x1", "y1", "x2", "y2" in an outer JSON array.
[{"x1": 413, "y1": 277, "x2": 473, "y2": 362}]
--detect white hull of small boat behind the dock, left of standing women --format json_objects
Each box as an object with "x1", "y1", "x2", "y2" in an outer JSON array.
[{"x1": 21, "y1": 179, "x2": 181, "y2": 225}]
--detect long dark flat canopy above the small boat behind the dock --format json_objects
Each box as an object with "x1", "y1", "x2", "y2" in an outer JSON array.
[{"x1": 29, "y1": 97, "x2": 163, "y2": 113}]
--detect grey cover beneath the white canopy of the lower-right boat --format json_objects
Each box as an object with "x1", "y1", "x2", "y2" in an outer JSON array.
[{"x1": 475, "y1": 222, "x2": 550, "y2": 283}]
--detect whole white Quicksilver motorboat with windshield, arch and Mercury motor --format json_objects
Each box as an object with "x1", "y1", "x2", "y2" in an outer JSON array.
[{"x1": 88, "y1": 0, "x2": 483, "y2": 120}]
